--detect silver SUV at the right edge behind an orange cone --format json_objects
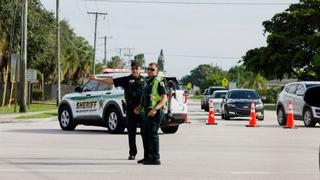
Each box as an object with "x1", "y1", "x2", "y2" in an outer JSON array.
[{"x1": 277, "y1": 81, "x2": 320, "y2": 127}]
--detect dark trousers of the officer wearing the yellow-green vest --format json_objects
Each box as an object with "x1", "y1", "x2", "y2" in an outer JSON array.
[{"x1": 144, "y1": 109, "x2": 164, "y2": 160}]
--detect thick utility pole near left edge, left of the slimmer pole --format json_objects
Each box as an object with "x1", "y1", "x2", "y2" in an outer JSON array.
[{"x1": 19, "y1": 0, "x2": 28, "y2": 112}]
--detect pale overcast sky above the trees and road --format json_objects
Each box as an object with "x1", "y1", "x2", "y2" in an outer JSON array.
[{"x1": 41, "y1": 0, "x2": 297, "y2": 78}]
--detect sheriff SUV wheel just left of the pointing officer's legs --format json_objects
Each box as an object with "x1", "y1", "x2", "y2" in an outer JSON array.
[{"x1": 105, "y1": 107, "x2": 124, "y2": 134}]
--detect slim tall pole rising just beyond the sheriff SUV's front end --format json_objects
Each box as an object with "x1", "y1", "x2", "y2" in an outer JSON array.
[{"x1": 56, "y1": 0, "x2": 61, "y2": 106}]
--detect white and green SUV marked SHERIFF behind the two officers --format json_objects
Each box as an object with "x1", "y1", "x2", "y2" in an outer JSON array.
[{"x1": 58, "y1": 73, "x2": 187, "y2": 134}]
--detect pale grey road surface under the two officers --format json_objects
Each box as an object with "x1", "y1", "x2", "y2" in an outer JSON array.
[{"x1": 0, "y1": 103, "x2": 320, "y2": 180}]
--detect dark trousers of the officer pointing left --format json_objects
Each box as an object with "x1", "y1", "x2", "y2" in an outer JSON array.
[{"x1": 126, "y1": 107, "x2": 148, "y2": 157}]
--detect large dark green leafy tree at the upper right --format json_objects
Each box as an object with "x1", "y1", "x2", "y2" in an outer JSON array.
[{"x1": 243, "y1": 0, "x2": 320, "y2": 80}]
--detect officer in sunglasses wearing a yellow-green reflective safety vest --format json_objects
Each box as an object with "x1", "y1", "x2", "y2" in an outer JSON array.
[{"x1": 135, "y1": 63, "x2": 167, "y2": 165}]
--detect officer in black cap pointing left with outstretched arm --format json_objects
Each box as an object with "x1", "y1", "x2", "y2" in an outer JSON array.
[{"x1": 90, "y1": 61, "x2": 148, "y2": 160}]
